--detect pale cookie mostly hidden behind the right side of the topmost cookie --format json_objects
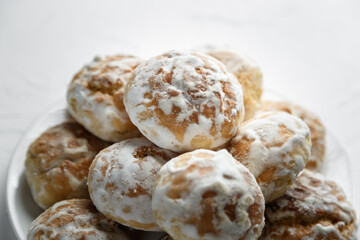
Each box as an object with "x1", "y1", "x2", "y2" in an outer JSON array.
[{"x1": 206, "y1": 48, "x2": 263, "y2": 120}]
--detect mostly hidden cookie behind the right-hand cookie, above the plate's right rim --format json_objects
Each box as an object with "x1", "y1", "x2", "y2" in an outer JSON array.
[{"x1": 260, "y1": 101, "x2": 325, "y2": 170}]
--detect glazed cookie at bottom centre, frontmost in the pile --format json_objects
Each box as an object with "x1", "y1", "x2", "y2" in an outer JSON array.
[{"x1": 152, "y1": 149, "x2": 265, "y2": 240}]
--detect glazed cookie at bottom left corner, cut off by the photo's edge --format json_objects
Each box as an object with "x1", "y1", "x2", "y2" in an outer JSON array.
[{"x1": 27, "y1": 199, "x2": 130, "y2": 240}]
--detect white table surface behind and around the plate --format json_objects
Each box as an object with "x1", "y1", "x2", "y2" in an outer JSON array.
[{"x1": 0, "y1": 0, "x2": 360, "y2": 240}]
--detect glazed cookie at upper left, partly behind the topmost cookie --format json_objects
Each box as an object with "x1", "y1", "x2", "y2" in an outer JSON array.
[{"x1": 67, "y1": 55, "x2": 140, "y2": 142}]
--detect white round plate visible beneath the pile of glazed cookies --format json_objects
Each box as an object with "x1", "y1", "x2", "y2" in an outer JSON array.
[{"x1": 7, "y1": 98, "x2": 354, "y2": 240}]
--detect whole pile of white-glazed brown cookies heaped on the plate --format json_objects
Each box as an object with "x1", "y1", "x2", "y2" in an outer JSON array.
[{"x1": 26, "y1": 49, "x2": 357, "y2": 240}]
